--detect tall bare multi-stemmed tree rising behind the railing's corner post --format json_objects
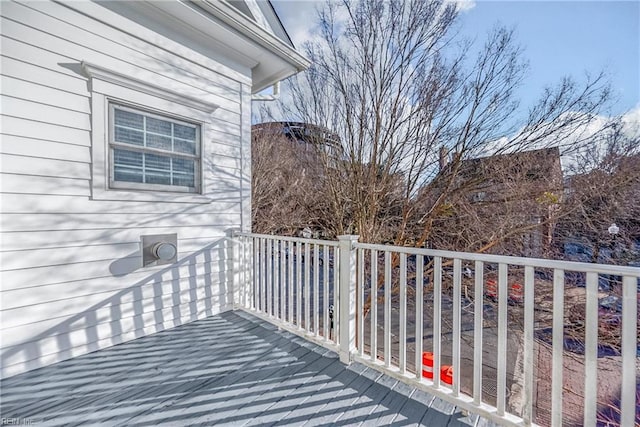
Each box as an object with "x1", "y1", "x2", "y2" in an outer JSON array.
[{"x1": 282, "y1": 2, "x2": 458, "y2": 241}]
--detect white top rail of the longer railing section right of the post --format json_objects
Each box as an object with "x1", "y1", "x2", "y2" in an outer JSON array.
[{"x1": 355, "y1": 243, "x2": 640, "y2": 278}]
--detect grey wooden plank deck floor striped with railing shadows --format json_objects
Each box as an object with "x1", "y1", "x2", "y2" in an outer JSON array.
[{"x1": 0, "y1": 312, "x2": 484, "y2": 426}]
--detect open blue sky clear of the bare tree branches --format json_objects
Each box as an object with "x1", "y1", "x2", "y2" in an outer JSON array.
[{"x1": 272, "y1": 0, "x2": 640, "y2": 115}]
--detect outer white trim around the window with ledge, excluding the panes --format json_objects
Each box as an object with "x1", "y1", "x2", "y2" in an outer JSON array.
[{"x1": 82, "y1": 62, "x2": 218, "y2": 203}]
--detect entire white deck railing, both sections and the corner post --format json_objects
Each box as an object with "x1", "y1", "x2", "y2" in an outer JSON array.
[{"x1": 232, "y1": 233, "x2": 640, "y2": 426}]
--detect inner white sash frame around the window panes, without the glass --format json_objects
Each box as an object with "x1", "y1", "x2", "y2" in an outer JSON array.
[{"x1": 108, "y1": 102, "x2": 202, "y2": 194}]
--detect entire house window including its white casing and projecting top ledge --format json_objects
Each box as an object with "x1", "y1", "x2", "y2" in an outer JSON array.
[{"x1": 82, "y1": 62, "x2": 217, "y2": 203}]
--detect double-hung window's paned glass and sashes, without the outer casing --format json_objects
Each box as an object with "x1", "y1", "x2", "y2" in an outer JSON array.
[{"x1": 109, "y1": 103, "x2": 201, "y2": 193}]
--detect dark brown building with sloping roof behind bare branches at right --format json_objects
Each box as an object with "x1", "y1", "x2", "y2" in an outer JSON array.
[{"x1": 418, "y1": 147, "x2": 563, "y2": 257}]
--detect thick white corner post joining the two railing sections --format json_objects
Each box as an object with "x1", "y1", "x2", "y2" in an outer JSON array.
[{"x1": 338, "y1": 235, "x2": 359, "y2": 364}]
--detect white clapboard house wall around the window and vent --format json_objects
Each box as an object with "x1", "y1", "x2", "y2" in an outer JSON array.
[{"x1": 0, "y1": 2, "x2": 251, "y2": 377}]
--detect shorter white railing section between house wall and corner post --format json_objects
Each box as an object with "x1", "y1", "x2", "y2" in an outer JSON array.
[{"x1": 237, "y1": 234, "x2": 339, "y2": 350}]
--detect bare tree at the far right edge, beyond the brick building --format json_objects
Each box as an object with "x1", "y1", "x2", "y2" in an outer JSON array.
[{"x1": 556, "y1": 120, "x2": 640, "y2": 264}]
